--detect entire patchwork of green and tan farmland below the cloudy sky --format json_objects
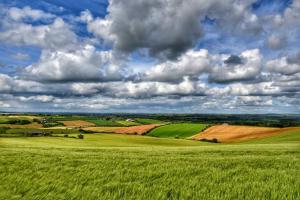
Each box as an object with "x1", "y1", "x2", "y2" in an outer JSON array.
[{"x1": 0, "y1": 114, "x2": 300, "y2": 199}]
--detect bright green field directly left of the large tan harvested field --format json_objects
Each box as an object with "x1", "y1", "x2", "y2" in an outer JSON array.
[{"x1": 147, "y1": 123, "x2": 207, "y2": 138}]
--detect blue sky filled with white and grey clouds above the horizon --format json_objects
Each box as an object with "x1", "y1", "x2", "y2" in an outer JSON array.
[{"x1": 0, "y1": 0, "x2": 300, "y2": 114}]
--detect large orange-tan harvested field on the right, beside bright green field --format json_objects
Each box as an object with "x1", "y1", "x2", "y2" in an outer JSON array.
[{"x1": 191, "y1": 125, "x2": 300, "y2": 142}]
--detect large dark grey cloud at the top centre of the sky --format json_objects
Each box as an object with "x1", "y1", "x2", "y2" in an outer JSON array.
[{"x1": 85, "y1": 0, "x2": 262, "y2": 58}]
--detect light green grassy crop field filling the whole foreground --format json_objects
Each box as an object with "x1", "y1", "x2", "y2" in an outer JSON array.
[{"x1": 0, "y1": 133, "x2": 300, "y2": 200}]
